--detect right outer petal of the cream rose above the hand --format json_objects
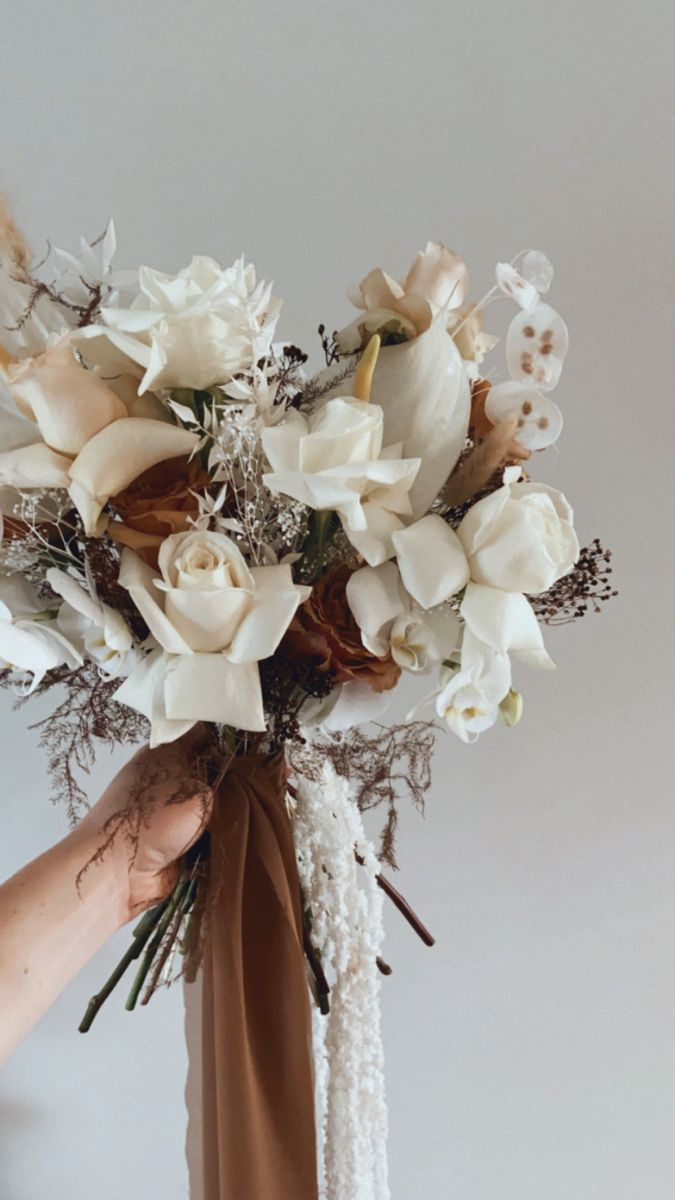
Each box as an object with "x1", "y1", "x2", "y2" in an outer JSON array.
[{"x1": 226, "y1": 564, "x2": 311, "y2": 662}]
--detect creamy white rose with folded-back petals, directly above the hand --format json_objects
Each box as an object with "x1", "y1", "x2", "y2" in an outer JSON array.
[{"x1": 115, "y1": 530, "x2": 309, "y2": 745}]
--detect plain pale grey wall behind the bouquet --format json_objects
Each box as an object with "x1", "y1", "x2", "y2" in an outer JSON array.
[{"x1": 0, "y1": 0, "x2": 675, "y2": 1200}]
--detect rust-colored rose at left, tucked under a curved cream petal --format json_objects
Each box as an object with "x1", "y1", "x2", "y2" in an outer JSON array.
[{"x1": 108, "y1": 457, "x2": 209, "y2": 566}]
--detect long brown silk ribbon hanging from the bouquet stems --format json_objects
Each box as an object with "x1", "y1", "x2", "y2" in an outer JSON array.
[{"x1": 202, "y1": 755, "x2": 318, "y2": 1200}]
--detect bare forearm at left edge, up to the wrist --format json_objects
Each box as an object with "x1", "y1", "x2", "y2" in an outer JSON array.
[{"x1": 0, "y1": 832, "x2": 129, "y2": 1061}]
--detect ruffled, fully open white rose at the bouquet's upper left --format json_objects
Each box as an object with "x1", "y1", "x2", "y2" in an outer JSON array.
[{"x1": 79, "y1": 257, "x2": 280, "y2": 394}]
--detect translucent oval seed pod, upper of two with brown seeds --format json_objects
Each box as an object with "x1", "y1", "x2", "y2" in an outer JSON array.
[{"x1": 506, "y1": 304, "x2": 569, "y2": 391}]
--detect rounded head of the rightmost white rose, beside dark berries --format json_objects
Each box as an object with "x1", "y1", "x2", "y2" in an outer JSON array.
[{"x1": 458, "y1": 484, "x2": 579, "y2": 594}]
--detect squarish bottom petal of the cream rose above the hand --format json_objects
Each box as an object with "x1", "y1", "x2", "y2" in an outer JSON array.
[{"x1": 165, "y1": 654, "x2": 265, "y2": 732}]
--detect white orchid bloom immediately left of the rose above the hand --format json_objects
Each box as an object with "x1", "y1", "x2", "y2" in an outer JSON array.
[{"x1": 47, "y1": 566, "x2": 141, "y2": 679}]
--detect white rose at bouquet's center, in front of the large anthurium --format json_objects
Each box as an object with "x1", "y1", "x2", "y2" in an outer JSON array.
[{"x1": 262, "y1": 396, "x2": 419, "y2": 565}]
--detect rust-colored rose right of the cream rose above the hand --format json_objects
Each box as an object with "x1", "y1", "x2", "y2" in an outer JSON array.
[{"x1": 283, "y1": 566, "x2": 401, "y2": 691}]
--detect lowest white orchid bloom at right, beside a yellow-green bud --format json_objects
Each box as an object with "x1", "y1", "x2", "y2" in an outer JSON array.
[{"x1": 436, "y1": 629, "x2": 510, "y2": 742}]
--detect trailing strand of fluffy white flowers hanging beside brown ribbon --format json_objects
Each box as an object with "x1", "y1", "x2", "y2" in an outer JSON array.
[{"x1": 293, "y1": 763, "x2": 389, "y2": 1200}]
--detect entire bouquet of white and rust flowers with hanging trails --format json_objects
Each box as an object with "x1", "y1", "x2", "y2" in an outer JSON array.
[{"x1": 0, "y1": 210, "x2": 611, "y2": 1200}]
